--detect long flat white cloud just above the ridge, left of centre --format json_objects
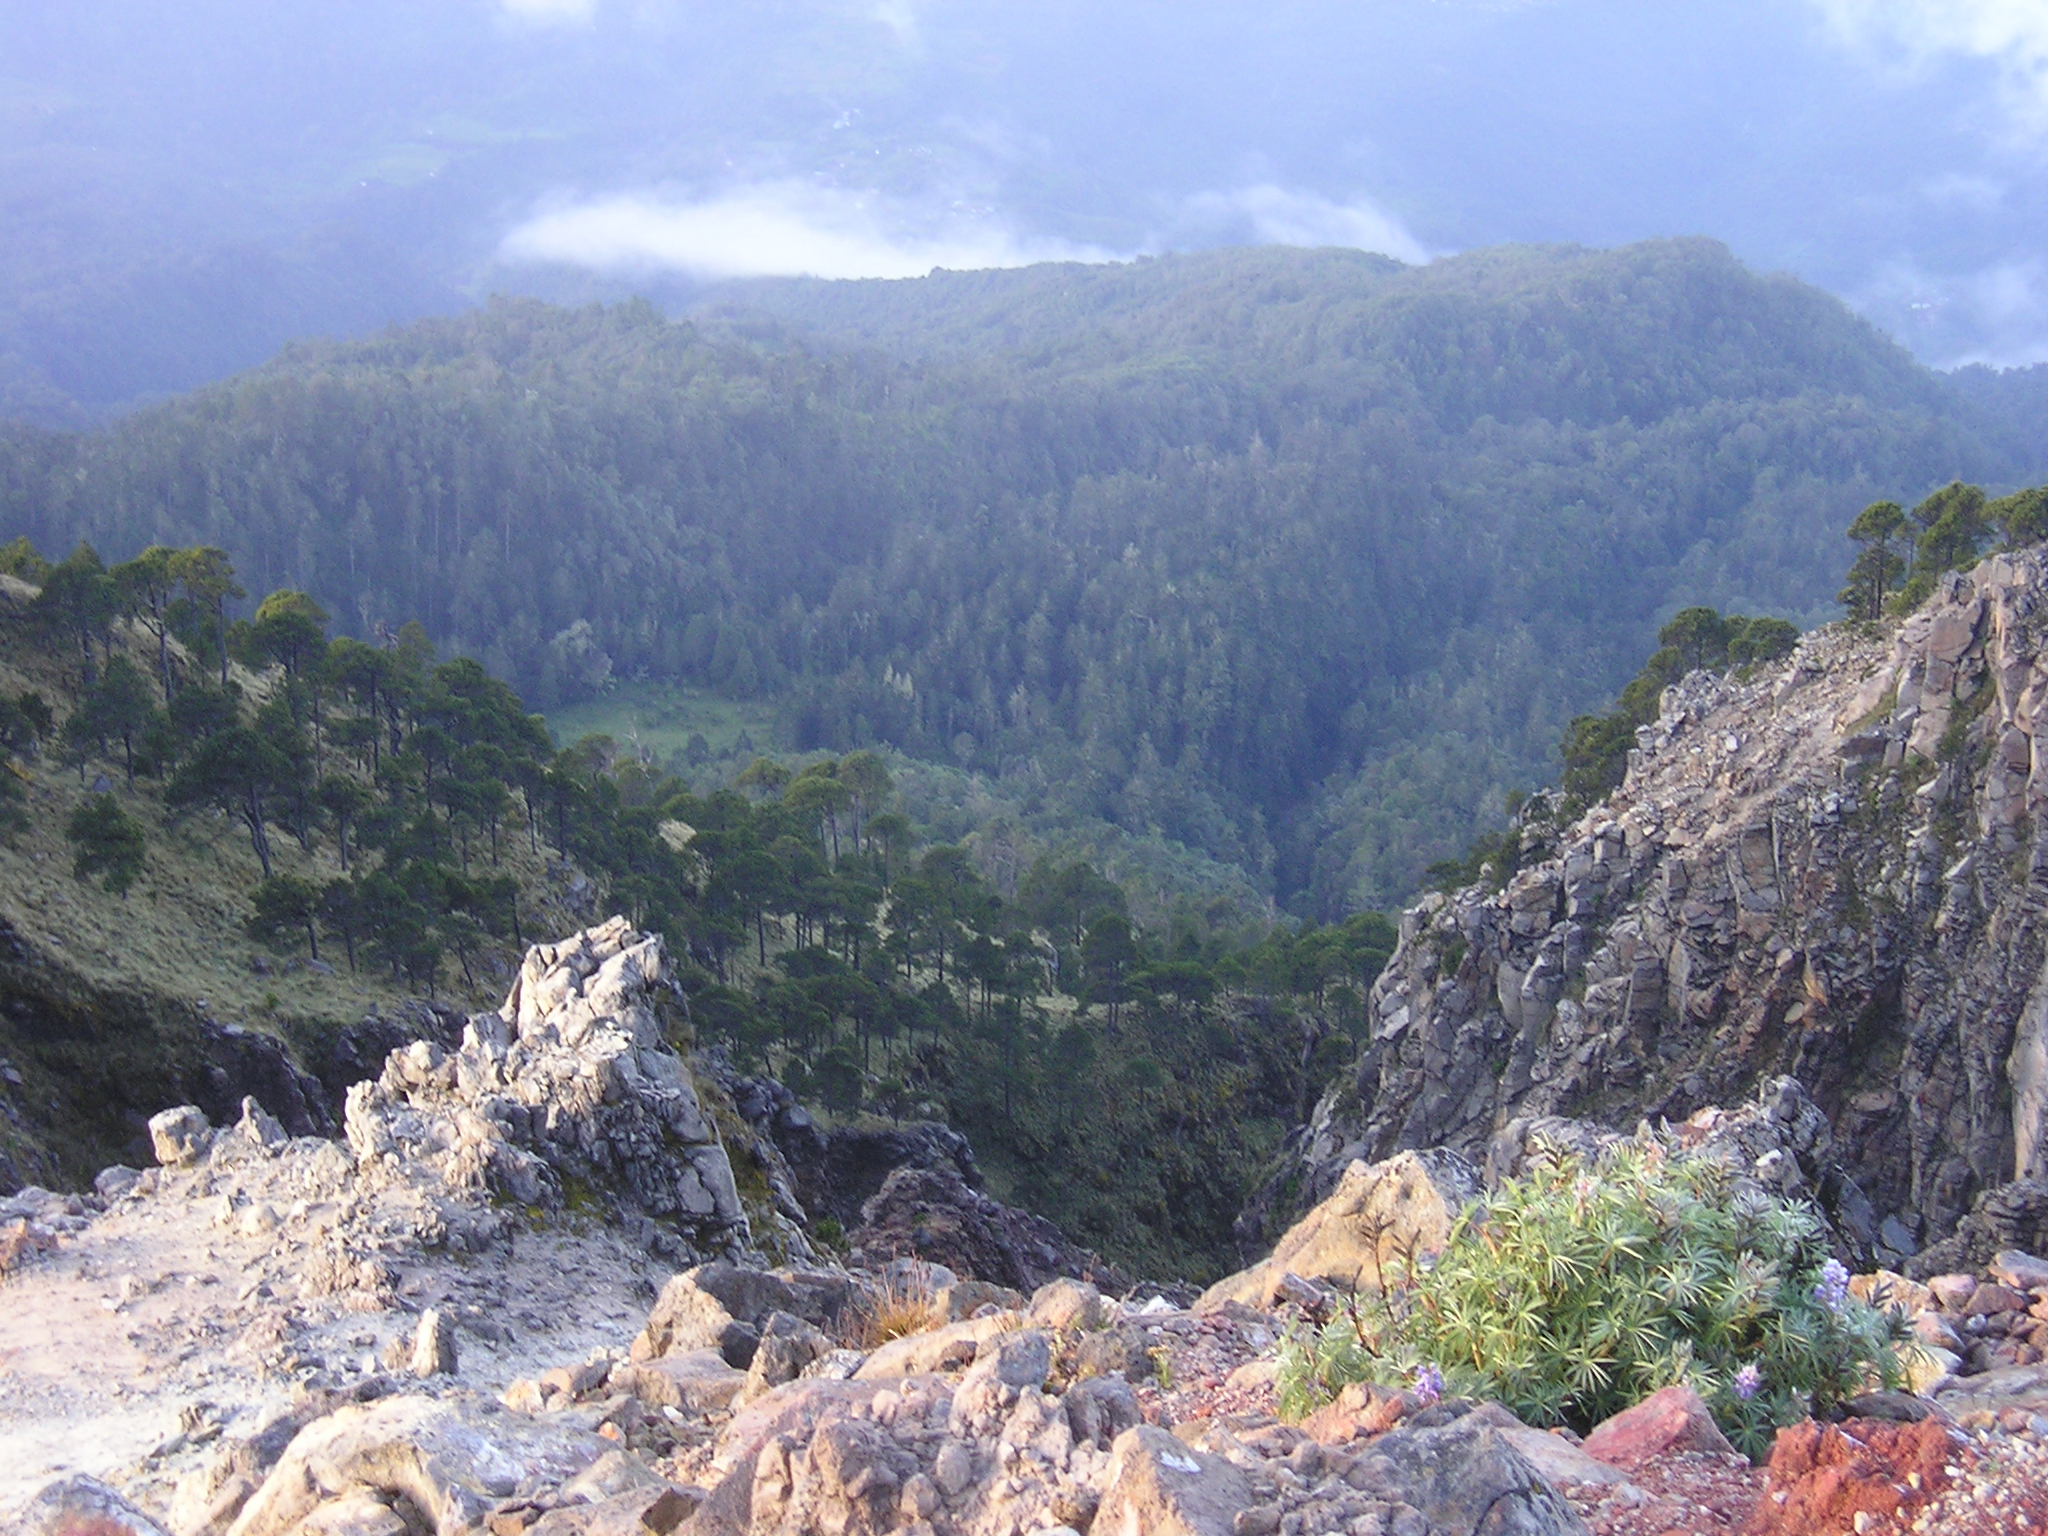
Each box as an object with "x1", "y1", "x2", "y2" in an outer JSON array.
[{"x1": 500, "y1": 182, "x2": 1110, "y2": 279}]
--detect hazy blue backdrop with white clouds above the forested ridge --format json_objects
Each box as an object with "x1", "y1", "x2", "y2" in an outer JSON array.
[{"x1": 0, "y1": 0, "x2": 2048, "y2": 408}]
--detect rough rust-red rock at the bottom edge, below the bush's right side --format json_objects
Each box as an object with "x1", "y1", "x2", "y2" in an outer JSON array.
[{"x1": 1743, "y1": 1419, "x2": 1952, "y2": 1536}]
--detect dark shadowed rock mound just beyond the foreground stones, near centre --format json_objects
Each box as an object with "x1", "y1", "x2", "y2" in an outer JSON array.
[{"x1": 848, "y1": 1165, "x2": 1133, "y2": 1292}]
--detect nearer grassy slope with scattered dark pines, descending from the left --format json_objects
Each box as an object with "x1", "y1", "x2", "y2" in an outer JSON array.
[{"x1": 0, "y1": 541, "x2": 1395, "y2": 1276}]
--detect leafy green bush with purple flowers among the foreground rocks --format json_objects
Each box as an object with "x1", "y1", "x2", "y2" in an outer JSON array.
[{"x1": 1280, "y1": 1141, "x2": 1903, "y2": 1456}]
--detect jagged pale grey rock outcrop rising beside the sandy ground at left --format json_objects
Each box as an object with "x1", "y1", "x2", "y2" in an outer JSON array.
[{"x1": 346, "y1": 918, "x2": 745, "y2": 1253}]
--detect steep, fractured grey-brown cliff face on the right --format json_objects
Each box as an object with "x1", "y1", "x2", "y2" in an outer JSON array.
[{"x1": 1266, "y1": 549, "x2": 2048, "y2": 1268}]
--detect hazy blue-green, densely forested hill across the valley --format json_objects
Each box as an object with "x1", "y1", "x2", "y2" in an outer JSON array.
[{"x1": 0, "y1": 242, "x2": 2044, "y2": 915}]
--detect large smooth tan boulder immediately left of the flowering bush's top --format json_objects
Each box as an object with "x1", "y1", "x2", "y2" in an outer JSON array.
[{"x1": 1196, "y1": 1151, "x2": 1479, "y2": 1311}]
